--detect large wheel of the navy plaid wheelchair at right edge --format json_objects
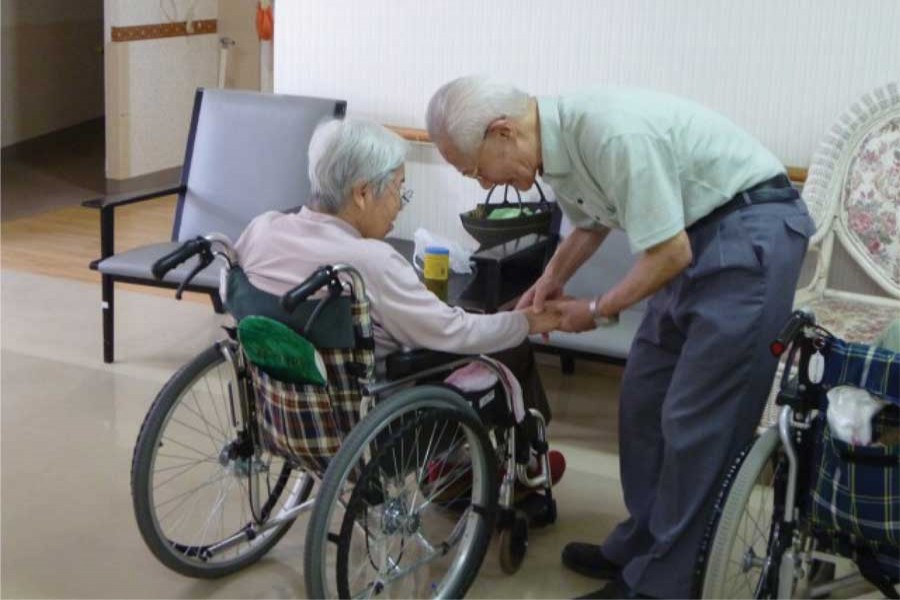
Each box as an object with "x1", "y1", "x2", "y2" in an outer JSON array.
[{"x1": 699, "y1": 427, "x2": 790, "y2": 598}]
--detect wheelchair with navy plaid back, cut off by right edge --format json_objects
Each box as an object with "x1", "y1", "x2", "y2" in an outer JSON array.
[{"x1": 695, "y1": 311, "x2": 900, "y2": 598}]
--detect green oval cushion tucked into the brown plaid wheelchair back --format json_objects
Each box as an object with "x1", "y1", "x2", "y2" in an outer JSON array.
[{"x1": 238, "y1": 316, "x2": 327, "y2": 385}]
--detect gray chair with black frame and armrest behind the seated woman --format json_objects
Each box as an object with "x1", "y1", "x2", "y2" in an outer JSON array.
[{"x1": 83, "y1": 89, "x2": 347, "y2": 363}]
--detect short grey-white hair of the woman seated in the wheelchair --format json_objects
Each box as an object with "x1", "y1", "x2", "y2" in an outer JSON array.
[{"x1": 309, "y1": 118, "x2": 409, "y2": 214}]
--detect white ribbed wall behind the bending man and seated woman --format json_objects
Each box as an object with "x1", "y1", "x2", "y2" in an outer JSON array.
[{"x1": 275, "y1": 0, "x2": 900, "y2": 246}]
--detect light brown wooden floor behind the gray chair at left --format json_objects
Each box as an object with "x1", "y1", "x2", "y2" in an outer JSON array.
[{"x1": 0, "y1": 195, "x2": 209, "y2": 302}]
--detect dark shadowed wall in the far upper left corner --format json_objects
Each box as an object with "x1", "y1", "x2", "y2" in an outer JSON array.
[{"x1": 0, "y1": 0, "x2": 103, "y2": 147}]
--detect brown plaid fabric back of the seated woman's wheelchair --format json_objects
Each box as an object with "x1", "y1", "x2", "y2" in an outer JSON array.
[{"x1": 250, "y1": 300, "x2": 375, "y2": 473}]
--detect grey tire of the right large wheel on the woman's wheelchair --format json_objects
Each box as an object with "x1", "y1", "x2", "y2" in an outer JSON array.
[{"x1": 303, "y1": 386, "x2": 498, "y2": 598}]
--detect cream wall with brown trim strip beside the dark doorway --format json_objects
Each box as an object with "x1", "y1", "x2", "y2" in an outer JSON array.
[{"x1": 105, "y1": 0, "x2": 219, "y2": 179}]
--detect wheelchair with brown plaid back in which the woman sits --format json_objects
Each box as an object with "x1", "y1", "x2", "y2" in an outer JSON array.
[{"x1": 131, "y1": 234, "x2": 556, "y2": 598}]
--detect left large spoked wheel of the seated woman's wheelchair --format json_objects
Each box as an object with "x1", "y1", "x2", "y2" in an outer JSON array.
[{"x1": 131, "y1": 344, "x2": 313, "y2": 578}]
